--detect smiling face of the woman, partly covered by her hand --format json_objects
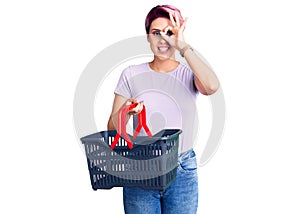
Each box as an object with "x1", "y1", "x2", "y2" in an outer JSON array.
[{"x1": 148, "y1": 18, "x2": 175, "y2": 60}]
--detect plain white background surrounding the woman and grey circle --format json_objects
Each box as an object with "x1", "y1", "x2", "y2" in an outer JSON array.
[{"x1": 0, "y1": 0, "x2": 300, "y2": 214}]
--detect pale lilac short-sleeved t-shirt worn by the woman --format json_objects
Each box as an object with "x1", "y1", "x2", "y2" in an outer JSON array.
[{"x1": 115, "y1": 63, "x2": 198, "y2": 153}]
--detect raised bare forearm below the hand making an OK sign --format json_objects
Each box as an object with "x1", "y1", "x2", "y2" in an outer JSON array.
[{"x1": 179, "y1": 44, "x2": 220, "y2": 95}]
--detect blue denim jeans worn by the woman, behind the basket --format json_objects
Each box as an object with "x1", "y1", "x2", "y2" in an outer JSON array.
[{"x1": 123, "y1": 150, "x2": 198, "y2": 214}]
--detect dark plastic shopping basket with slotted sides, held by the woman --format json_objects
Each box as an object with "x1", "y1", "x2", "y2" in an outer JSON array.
[{"x1": 81, "y1": 102, "x2": 182, "y2": 190}]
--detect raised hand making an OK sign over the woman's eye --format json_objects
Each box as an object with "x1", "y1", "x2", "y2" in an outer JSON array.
[{"x1": 161, "y1": 13, "x2": 187, "y2": 50}]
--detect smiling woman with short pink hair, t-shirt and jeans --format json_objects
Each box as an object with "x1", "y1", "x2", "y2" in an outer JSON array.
[{"x1": 108, "y1": 5, "x2": 219, "y2": 214}]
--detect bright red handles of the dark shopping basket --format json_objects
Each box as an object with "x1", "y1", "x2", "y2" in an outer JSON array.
[{"x1": 110, "y1": 103, "x2": 152, "y2": 149}]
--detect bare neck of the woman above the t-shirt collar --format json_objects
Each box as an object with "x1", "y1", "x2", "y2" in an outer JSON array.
[{"x1": 149, "y1": 57, "x2": 179, "y2": 73}]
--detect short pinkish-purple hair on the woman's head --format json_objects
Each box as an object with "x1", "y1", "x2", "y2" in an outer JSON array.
[{"x1": 145, "y1": 5, "x2": 183, "y2": 34}]
